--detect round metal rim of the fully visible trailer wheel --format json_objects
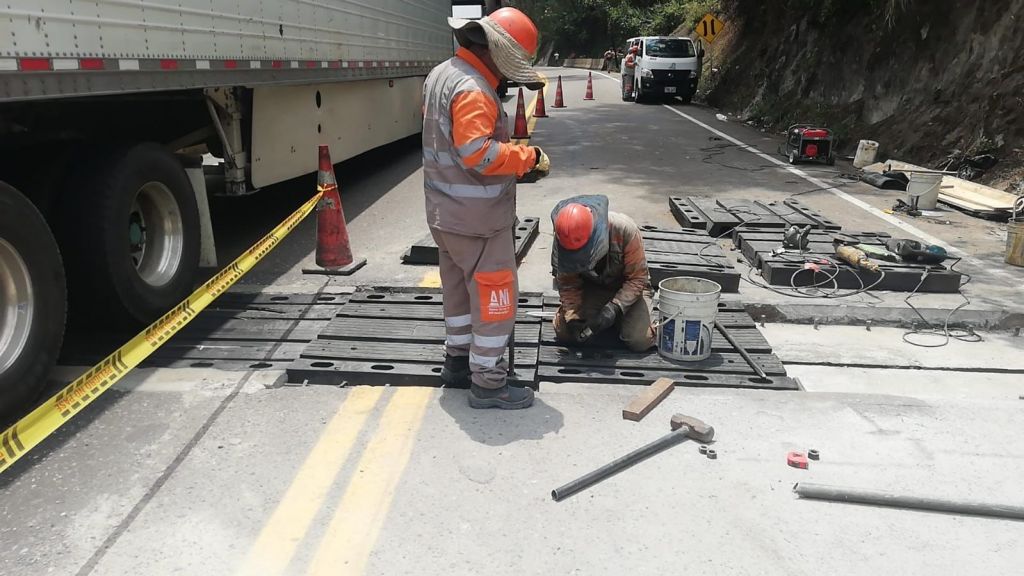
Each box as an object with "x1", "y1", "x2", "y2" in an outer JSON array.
[{"x1": 128, "y1": 181, "x2": 185, "y2": 286}]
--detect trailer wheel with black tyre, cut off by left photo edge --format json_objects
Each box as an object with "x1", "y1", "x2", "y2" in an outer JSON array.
[{"x1": 0, "y1": 182, "x2": 67, "y2": 409}]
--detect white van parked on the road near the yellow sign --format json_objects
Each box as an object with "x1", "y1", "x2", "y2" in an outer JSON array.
[{"x1": 622, "y1": 36, "x2": 703, "y2": 104}]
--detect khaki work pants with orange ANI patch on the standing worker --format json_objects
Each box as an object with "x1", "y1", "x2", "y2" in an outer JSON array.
[{"x1": 430, "y1": 227, "x2": 519, "y2": 388}]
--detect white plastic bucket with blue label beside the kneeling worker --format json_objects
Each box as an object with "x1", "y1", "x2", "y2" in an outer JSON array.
[{"x1": 657, "y1": 276, "x2": 722, "y2": 362}]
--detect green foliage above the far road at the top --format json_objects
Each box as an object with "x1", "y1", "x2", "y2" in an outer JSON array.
[{"x1": 509, "y1": 0, "x2": 719, "y2": 56}]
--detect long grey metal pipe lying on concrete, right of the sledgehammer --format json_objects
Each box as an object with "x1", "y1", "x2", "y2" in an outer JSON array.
[{"x1": 793, "y1": 482, "x2": 1024, "y2": 520}]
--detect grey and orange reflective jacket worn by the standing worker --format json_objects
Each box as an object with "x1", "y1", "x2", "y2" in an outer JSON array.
[{"x1": 423, "y1": 48, "x2": 537, "y2": 238}]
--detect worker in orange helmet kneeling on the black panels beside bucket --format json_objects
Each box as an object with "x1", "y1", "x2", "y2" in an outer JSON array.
[{"x1": 551, "y1": 196, "x2": 655, "y2": 352}]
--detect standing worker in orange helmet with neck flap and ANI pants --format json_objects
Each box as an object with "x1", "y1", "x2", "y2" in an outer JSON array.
[{"x1": 423, "y1": 8, "x2": 551, "y2": 409}]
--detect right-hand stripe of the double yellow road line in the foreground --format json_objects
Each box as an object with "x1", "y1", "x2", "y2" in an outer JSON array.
[{"x1": 308, "y1": 387, "x2": 433, "y2": 576}]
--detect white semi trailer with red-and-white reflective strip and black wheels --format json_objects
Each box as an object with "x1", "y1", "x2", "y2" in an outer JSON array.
[{"x1": 0, "y1": 0, "x2": 452, "y2": 414}]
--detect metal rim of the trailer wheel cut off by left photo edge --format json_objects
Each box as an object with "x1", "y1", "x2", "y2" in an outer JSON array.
[{"x1": 0, "y1": 238, "x2": 36, "y2": 372}]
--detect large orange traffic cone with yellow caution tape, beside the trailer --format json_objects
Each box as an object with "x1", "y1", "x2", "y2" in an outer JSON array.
[{"x1": 302, "y1": 145, "x2": 367, "y2": 276}]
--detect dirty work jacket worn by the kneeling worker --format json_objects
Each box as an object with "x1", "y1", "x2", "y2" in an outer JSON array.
[{"x1": 555, "y1": 212, "x2": 651, "y2": 321}]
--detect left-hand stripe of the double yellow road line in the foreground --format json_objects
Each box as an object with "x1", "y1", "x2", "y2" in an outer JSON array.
[{"x1": 238, "y1": 386, "x2": 384, "y2": 575}]
